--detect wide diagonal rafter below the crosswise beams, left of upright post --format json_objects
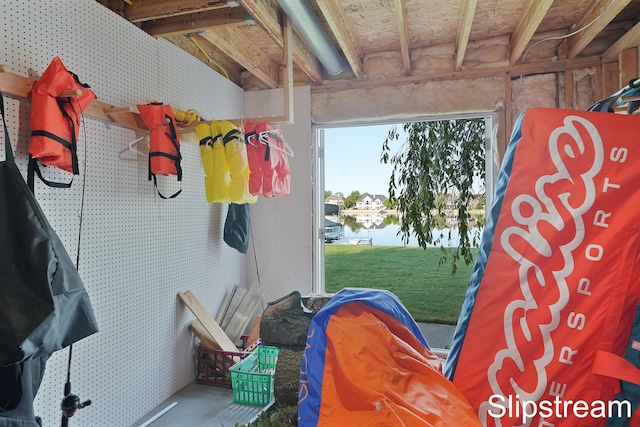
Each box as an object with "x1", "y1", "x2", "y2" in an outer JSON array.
[{"x1": 203, "y1": 28, "x2": 279, "y2": 89}]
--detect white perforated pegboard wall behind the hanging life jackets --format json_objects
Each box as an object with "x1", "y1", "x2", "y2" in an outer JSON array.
[{"x1": 0, "y1": 0, "x2": 246, "y2": 427}]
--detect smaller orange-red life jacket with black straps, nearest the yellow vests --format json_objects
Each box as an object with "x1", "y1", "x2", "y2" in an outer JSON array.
[{"x1": 138, "y1": 104, "x2": 182, "y2": 199}]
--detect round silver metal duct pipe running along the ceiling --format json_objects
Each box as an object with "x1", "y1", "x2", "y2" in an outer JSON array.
[{"x1": 278, "y1": 0, "x2": 343, "y2": 75}]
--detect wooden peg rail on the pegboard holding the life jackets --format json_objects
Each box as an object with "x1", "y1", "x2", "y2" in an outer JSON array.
[{"x1": 0, "y1": 65, "x2": 290, "y2": 144}]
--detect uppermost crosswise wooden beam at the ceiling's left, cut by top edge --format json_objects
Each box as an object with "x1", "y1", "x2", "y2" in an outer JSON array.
[{"x1": 124, "y1": 0, "x2": 229, "y2": 22}]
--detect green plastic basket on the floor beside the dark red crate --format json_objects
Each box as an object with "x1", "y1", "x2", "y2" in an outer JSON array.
[{"x1": 229, "y1": 345, "x2": 280, "y2": 406}]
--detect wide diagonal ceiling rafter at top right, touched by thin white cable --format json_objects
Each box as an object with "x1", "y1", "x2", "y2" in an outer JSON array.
[{"x1": 567, "y1": 0, "x2": 631, "y2": 58}]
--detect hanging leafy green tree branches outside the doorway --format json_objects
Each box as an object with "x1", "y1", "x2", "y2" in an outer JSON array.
[{"x1": 380, "y1": 119, "x2": 485, "y2": 273}]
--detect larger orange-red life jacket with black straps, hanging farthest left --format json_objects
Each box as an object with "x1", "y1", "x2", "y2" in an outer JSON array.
[{"x1": 29, "y1": 56, "x2": 97, "y2": 188}]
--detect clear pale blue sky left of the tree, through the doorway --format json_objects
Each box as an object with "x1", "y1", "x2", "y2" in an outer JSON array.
[{"x1": 324, "y1": 124, "x2": 404, "y2": 196}]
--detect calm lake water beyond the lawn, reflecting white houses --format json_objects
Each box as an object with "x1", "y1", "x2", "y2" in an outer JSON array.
[{"x1": 328, "y1": 213, "x2": 480, "y2": 247}]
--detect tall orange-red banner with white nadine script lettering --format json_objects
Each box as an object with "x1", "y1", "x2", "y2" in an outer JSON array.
[{"x1": 447, "y1": 109, "x2": 640, "y2": 426}]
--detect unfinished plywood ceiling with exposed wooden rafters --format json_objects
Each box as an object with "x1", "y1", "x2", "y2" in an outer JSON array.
[{"x1": 98, "y1": 0, "x2": 640, "y2": 91}]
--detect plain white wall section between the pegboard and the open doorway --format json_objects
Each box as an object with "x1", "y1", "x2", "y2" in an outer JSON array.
[{"x1": 245, "y1": 86, "x2": 315, "y2": 302}]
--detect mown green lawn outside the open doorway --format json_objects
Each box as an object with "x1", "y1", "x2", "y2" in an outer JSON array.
[{"x1": 325, "y1": 244, "x2": 473, "y2": 324}]
